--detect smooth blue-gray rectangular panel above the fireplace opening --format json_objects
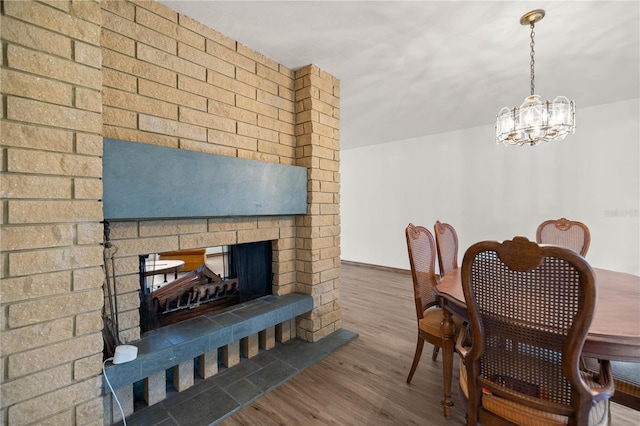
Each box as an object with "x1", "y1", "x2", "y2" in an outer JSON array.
[{"x1": 102, "y1": 138, "x2": 307, "y2": 220}]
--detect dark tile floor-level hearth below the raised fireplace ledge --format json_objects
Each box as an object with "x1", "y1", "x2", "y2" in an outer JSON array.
[{"x1": 119, "y1": 329, "x2": 357, "y2": 426}]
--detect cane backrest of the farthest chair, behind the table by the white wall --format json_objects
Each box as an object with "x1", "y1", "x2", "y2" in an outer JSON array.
[{"x1": 536, "y1": 217, "x2": 591, "y2": 257}]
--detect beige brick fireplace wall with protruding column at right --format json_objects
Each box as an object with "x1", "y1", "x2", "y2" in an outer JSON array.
[{"x1": 0, "y1": 0, "x2": 340, "y2": 425}]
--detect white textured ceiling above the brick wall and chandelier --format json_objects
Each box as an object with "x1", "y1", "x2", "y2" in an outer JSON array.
[{"x1": 161, "y1": 0, "x2": 640, "y2": 149}]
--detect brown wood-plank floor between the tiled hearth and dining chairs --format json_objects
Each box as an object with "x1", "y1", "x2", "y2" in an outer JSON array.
[{"x1": 220, "y1": 263, "x2": 640, "y2": 426}]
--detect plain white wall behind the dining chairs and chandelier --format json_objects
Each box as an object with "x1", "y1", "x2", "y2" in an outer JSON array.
[{"x1": 340, "y1": 99, "x2": 640, "y2": 274}]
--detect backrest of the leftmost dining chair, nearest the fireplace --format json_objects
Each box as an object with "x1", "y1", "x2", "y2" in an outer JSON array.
[{"x1": 405, "y1": 223, "x2": 436, "y2": 319}]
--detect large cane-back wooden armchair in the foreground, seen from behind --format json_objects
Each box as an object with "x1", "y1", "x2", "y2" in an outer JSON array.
[{"x1": 456, "y1": 237, "x2": 614, "y2": 426}]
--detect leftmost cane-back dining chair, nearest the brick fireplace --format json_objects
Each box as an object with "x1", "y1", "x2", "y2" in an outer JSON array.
[{"x1": 405, "y1": 223, "x2": 461, "y2": 383}]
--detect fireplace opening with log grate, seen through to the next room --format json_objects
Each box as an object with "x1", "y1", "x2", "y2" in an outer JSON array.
[{"x1": 139, "y1": 241, "x2": 273, "y2": 333}]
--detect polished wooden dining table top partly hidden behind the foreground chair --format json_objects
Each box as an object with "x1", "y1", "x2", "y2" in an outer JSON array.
[{"x1": 435, "y1": 268, "x2": 640, "y2": 362}]
